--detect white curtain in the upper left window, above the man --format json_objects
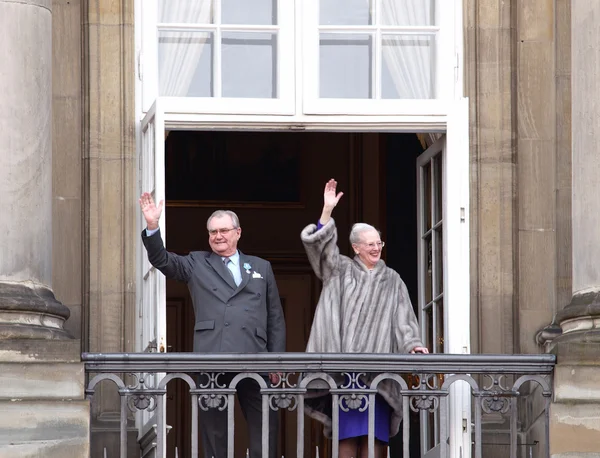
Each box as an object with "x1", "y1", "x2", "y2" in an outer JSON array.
[{"x1": 158, "y1": 0, "x2": 214, "y2": 97}]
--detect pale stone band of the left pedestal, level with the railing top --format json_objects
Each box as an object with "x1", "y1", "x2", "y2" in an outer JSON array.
[{"x1": 0, "y1": 363, "x2": 85, "y2": 400}]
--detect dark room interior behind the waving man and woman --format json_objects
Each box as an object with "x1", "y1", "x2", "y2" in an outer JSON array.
[{"x1": 166, "y1": 131, "x2": 364, "y2": 456}]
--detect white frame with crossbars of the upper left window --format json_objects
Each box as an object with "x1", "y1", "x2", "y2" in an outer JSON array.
[{"x1": 137, "y1": 0, "x2": 295, "y2": 116}]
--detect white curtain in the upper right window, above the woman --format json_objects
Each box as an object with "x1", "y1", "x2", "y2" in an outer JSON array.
[{"x1": 381, "y1": 0, "x2": 434, "y2": 99}]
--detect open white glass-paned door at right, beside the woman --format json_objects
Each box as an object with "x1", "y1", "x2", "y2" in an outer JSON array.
[{"x1": 417, "y1": 99, "x2": 471, "y2": 458}]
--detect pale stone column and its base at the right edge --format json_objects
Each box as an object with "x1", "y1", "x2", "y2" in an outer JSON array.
[{"x1": 556, "y1": 0, "x2": 600, "y2": 341}]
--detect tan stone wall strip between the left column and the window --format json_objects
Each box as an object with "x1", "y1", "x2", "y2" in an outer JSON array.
[{"x1": 82, "y1": 0, "x2": 139, "y2": 456}]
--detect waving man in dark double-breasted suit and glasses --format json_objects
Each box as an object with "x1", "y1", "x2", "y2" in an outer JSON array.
[{"x1": 140, "y1": 193, "x2": 285, "y2": 458}]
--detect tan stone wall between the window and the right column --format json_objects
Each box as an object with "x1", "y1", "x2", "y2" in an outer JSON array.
[{"x1": 465, "y1": 0, "x2": 571, "y2": 353}]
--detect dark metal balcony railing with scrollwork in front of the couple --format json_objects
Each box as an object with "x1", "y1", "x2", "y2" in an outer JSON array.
[{"x1": 82, "y1": 353, "x2": 555, "y2": 458}]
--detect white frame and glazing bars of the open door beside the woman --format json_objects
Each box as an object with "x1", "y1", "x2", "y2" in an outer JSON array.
[{"x1": 417, "y1": 99, "x2": 471, "y2": 458}]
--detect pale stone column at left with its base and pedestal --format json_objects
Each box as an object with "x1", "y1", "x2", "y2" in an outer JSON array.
[{"x1": 0, "y1": 0, "x2": 90, "y2": 458}]
